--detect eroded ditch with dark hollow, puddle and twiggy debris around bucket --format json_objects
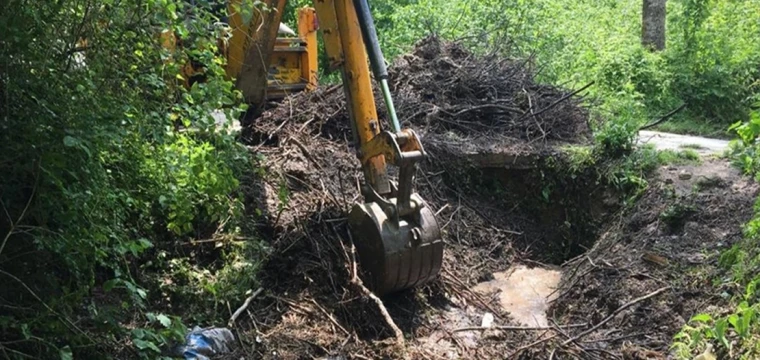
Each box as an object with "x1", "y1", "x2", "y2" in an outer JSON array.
[{"x1": 235, "y1": 134, "x2": 618, "y2": 358}]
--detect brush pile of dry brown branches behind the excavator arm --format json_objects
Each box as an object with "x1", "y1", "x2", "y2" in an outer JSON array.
[{"x1": 256, "y1": 37, "x2": 590, "y2": 146}]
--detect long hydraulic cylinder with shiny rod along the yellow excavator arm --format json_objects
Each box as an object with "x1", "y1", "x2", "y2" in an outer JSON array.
[{"x1": 353, "y1": 0, "x2": 401, "y2": 132}]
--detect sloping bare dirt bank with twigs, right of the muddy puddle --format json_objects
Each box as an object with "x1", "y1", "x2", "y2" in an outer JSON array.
[{"x1": 550, "y1": 159, "x2": 759, "y2": 359}]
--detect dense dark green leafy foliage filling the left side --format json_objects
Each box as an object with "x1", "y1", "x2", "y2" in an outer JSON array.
[{"x1": 0, "y1": 0, "x2": 255, "y2": 358}]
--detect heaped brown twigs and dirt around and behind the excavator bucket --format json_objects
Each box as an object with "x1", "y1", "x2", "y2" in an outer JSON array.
[{"x1": 229, "y1": 37, "x2": 590, "y2": 358}]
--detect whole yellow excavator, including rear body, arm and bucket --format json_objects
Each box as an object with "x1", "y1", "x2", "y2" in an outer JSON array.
[{"x1": 186, "y1": 0, "x2": 443, "y2": 295}]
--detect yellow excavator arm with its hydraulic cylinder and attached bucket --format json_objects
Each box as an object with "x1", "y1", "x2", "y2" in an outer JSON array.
[{"x1": 314, "y1": 0, "x2": 443, "y2": 295}]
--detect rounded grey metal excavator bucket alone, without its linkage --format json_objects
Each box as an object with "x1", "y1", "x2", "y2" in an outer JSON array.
[{"x1": 348, "y1": 197, "x2": 443, "y2": 295}]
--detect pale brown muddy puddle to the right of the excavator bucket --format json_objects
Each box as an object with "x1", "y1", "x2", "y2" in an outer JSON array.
[{"x1": 473, "y1": 265, "x2": 562, "y2": 326}]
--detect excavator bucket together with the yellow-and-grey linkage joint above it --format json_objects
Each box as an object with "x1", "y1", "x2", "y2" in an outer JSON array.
[{"x1": 348, "y1": 129, "x2": 443, "y2": 294}]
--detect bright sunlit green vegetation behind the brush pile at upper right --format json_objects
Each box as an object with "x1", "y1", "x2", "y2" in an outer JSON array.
[{"x1": 371, "y1": 0, "x2": 760, "y2": 135}]
